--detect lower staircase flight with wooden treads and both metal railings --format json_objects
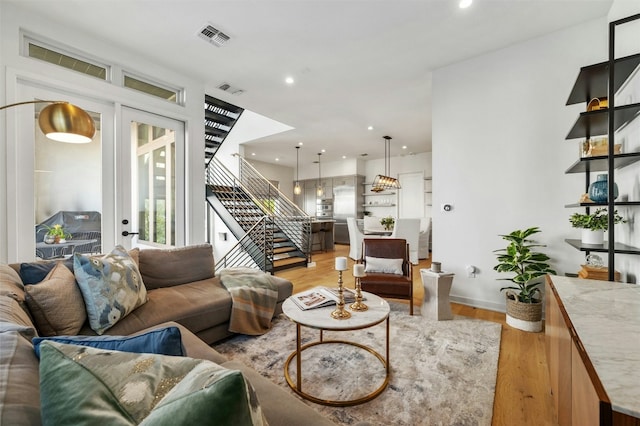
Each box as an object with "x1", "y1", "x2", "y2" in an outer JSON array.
[{"x1": 206, "y1": 156, "x2": 311, "y2": 273}]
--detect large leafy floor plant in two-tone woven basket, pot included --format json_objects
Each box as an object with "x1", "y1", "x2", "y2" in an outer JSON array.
[{"x1": 493, "y1": 227, "x2": 556, "y2": 332}]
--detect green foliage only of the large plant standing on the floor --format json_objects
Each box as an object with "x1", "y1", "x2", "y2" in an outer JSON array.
[{"x1": 493, "y1": 227, "x2": 556, "y2": 303}]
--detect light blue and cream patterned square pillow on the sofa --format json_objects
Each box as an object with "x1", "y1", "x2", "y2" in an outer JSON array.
[{"x1": 73, "y1": 246, "x2": 147, "y2": 334}]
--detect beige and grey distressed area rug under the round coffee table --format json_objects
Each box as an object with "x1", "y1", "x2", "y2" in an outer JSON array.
[{"x1": 213, "y1": 303, "x2": 501, "y2": 426}]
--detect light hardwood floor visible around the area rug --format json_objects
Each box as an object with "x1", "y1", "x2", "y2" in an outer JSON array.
[{"x1": 276, "y1": 245, "x2": 557, "y2": 426}]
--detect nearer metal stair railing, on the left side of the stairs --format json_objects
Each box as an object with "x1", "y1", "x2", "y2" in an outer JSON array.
[{"x1": 206, "y1": 157, "x2": 273, "y2": 272}]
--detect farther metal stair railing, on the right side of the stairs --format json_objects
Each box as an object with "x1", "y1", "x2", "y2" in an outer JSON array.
[{"x1": 234, "y1": 154, "x2": 311, "y2": 261}]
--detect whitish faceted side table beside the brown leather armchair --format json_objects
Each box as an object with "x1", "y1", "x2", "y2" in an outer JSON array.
[{"x1": 420, "y1": 269, "x2": 454, "y2": 321}]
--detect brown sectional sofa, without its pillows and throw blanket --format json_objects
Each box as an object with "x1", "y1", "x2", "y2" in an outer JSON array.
[{"x1": 0, "y1": 245, "x2": 333, "y2": 426}]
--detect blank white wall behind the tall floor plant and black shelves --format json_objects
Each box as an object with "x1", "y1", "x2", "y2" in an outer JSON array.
[{"x1": 432, "y1": 19, "x2": 607, "y2": 310}]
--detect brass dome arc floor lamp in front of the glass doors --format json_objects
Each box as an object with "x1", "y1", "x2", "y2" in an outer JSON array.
[{"x1": 0, "y1": 101, "x2": 96, "y2": 143}]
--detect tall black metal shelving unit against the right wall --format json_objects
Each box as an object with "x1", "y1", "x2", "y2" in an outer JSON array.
[{"x1": 565, "y1": 14, "x2": 640, "y2": 281}]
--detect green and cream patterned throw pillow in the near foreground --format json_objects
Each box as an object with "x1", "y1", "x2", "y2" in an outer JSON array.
[{"x1": 40, "y1": 341, "x2": 266, "y2": 426}]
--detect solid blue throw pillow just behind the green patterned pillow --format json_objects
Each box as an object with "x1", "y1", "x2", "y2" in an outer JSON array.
[{"x1": 32, "y1": 327, "x2": 186, "y2": 358}]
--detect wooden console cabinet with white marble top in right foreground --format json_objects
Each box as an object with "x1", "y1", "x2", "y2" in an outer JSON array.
[{"x1": 545, "y1": 276, "x2": 640, "y2": 426}]
